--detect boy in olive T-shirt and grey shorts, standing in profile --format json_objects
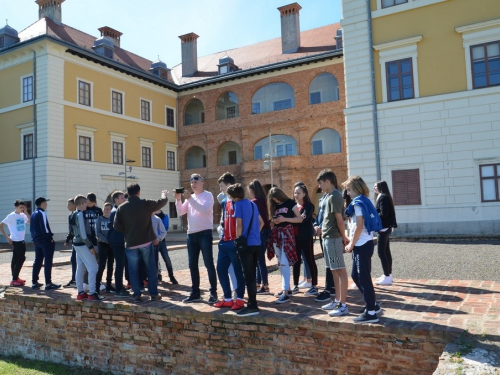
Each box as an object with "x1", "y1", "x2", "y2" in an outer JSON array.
[{"x1": 316, "y1": 169, "x2": 349, "y2": 316}]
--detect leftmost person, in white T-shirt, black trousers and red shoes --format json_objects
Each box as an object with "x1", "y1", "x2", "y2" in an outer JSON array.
[{"x1": 0, "y1": 199, "x2": 30, "y2": 286}]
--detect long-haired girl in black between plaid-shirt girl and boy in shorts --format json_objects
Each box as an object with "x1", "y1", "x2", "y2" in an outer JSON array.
[{"x1": 292, "y1": 182, "x2": 319, "y2": 296}]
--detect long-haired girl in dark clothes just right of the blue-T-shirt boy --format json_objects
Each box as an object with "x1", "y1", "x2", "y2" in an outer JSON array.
[{"x1": 248, "y1": 180, "x2": 271, "y2": 294}]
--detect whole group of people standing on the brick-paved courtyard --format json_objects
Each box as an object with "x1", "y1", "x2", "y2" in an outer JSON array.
[{"x1": 0, "y1": 169, "x2": 397, "y2": 323}]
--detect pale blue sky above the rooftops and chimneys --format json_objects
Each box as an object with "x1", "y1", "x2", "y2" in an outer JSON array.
[{"x1": 0, "y1": 0, "x2": 341, "y2": 68}]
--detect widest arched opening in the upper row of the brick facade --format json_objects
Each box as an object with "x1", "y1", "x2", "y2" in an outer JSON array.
[{"x1": 252, "y1": 83, "x2": 295, "y2": 115}]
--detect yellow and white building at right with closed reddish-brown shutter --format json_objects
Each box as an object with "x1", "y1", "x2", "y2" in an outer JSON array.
[{"x1": 341, "y1": 0, "x2": 500, "y2": 235}]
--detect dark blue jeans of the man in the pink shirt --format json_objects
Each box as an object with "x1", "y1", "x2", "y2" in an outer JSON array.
[{"x1": 187, "y1": 229, "x2": 217, "y2": 297}]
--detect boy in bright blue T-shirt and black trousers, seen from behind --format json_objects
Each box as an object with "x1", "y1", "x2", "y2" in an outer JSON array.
[{"x1": 227, "y1": 184, "x2": 264, "y2": 316}]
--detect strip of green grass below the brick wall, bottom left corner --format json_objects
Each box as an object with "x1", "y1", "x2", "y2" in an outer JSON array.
[{"x1": 0, "y1": 356, "x2": 108, "y2": 375}]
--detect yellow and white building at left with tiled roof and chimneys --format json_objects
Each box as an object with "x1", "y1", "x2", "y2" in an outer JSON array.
[{"x1": 0, "y1": 0, "x2": 179, "y2": 239}]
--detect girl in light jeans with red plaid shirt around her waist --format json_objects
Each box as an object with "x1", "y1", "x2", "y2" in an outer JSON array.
[{"x1": 267, "y1": 187, "x2": 302, "y2": 303}]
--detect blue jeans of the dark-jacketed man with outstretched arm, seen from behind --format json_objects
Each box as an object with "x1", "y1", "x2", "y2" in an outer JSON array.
[{"x1": 125, "y1": 242, "x2": 158, "y2": 297}]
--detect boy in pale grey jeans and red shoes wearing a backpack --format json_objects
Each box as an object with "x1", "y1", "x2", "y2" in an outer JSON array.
[{"x1": 69, "y1": 195, "x2": 104, "y2": 302}]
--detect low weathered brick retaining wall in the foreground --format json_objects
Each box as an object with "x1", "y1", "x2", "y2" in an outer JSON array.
[{"x1": 0, "y1": 291, "x2": 456, "y2": 374}]
